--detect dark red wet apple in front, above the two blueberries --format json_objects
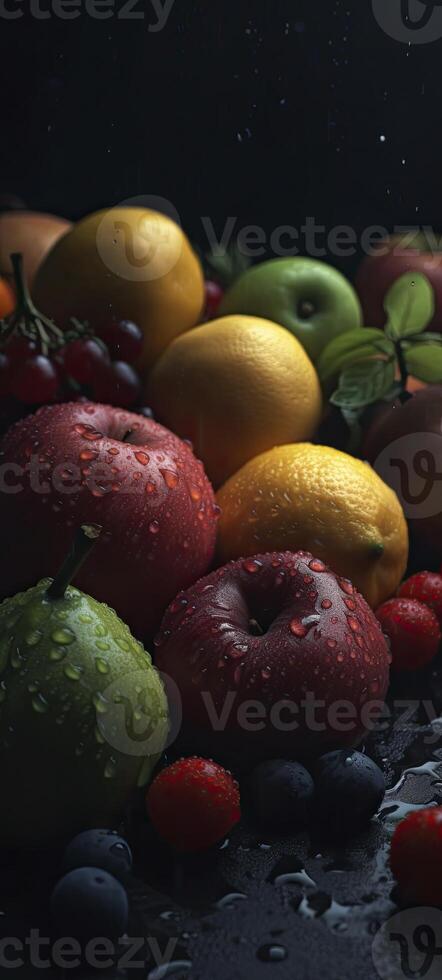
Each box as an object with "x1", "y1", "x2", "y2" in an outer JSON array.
[{"x1": 155, "y1": 551, "x2": 390, "y2": 764}]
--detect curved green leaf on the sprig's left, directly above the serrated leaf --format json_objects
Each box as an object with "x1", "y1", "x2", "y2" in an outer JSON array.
[{"x1": 316, "y1": 327, "x2": 394, "y2": 385}]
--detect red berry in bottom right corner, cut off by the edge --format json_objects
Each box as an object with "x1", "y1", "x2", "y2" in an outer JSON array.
[{"x1": 390, "y1": 806, "x2": 442, "y2": 907}]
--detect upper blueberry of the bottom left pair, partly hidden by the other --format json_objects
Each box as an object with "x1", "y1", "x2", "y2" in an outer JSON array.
[{"x1": 62, "y1": 830, "x2": 132, "y2": 878}]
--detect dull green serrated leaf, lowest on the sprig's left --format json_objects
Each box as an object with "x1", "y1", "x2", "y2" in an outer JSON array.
[{"x1": 330, "y1": 361, "x2": 395, "y2": 409}]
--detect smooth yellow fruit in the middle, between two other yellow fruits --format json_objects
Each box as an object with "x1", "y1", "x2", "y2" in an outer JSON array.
[{"x1": 147, "y1": 316, "x2": 321, "y2": 486}]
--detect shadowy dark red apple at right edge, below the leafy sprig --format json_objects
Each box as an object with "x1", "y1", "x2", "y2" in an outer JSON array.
[{"x1": 362, "y1": 385, "x2": 442, "y2": 568}]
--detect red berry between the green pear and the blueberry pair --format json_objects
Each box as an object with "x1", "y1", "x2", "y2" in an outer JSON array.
[{"x1": 146, "y1": 756, "x2": 241, "y2": 851}]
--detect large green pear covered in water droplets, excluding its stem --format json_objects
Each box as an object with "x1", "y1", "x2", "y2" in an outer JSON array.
[{"x1": 0, "y1": 580, "x2": 168, "y2": 846}]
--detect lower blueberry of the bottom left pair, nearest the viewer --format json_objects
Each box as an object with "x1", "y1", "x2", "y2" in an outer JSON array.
[{"x1": 51, "y1": 868, "x2": 129, "y2": 943}]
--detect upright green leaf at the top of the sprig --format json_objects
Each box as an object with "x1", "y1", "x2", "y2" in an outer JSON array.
[{"x1": 384, "y1": 272, "x2": 434, "y2": 340}]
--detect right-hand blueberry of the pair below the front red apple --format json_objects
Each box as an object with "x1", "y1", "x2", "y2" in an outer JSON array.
[{"x1": 315, "y1": 750, "x2": 385, "y2": 834}]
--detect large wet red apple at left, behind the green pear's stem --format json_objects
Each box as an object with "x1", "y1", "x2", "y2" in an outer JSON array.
[{"x1": 0, "y1": 402, "x2": 217, "y2": 637}]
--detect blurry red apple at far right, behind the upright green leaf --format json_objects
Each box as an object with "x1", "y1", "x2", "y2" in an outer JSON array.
[{"x1": 356, "y1": 234, "x2": 442, "y2": 331}]
